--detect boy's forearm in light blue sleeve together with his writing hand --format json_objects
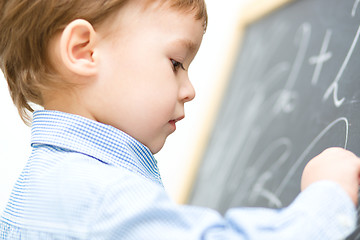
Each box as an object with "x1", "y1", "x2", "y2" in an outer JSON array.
[{"x1": 222, "y1": 148, "x2": 360, "y2": 239}]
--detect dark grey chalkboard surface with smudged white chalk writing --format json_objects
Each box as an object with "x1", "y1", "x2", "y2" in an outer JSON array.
[{"x1": 188, "y1": 0, "x2": 360, "y2": 239}]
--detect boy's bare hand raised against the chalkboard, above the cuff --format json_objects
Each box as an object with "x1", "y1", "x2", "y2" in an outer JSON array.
[{"x1": 301, "y1": 148, "x2": 360, "y2": 205}]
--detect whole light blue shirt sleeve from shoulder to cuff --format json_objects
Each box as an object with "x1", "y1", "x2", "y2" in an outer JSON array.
[{"x1": 89, "y1": 172, "x2": 356, "y2": 240}]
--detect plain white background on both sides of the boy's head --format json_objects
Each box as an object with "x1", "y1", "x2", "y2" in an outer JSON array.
[{"x1": 0, "y1": 0, "x2": 251, "y2": 210}]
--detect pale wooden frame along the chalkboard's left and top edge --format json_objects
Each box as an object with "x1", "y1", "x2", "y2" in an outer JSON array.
[{"x1": 177, "y1": 0, "x2": 295, "y2": 204}]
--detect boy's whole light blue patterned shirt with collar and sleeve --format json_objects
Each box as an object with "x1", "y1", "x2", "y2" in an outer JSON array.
[{"x1": 0, "y1": 111, "x2": 356, "y2": 240}]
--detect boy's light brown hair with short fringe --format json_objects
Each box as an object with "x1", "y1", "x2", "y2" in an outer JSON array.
[{"x1": 0, "y1": 0, "x2": 207, "y2": 124}]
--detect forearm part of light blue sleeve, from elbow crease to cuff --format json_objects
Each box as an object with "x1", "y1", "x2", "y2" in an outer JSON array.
[{"x1": 222, "y1": 181, "x2": 356, "y2": 240}]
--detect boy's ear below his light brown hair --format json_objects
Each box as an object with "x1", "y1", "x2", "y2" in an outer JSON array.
[{"x1": 60, "y1": 19, "x2": 97, "y2": 76}]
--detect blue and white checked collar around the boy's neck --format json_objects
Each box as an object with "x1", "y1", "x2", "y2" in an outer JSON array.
[{"x1": 31, "y1": 110, "x2": 162, "y2": 185}]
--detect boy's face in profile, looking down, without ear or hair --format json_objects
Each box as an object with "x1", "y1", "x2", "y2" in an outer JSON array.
[{"x1": 93, "y1": 3, "x2": 204, "y2": 153}]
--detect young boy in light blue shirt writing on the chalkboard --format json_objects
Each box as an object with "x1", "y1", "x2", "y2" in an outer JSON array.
[{"x1": 0, "y1": 0, "x2": 360, "y2": 240}]
